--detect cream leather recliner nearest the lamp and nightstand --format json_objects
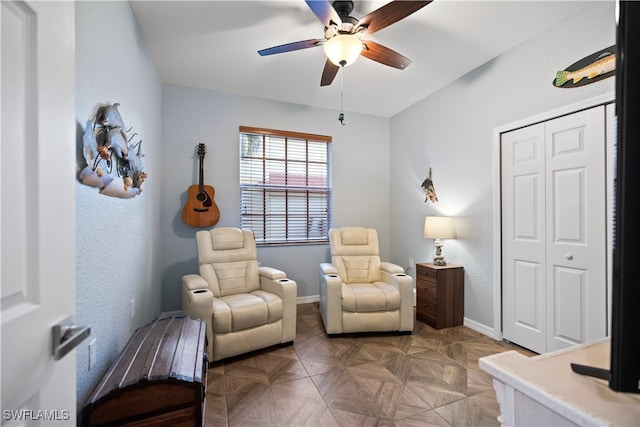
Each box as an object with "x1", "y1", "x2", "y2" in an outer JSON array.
[{"x1": 320, "y1": 227, "x2": 414, "y2": 335}]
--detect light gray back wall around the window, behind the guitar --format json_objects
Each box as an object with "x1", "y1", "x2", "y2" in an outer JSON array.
[{"x1": 159, "y1": 85, "x2": 391, "y2": 310}]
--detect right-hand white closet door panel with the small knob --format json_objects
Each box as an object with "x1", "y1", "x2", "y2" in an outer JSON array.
[{"x1": 546, "y1": 106, "x2": 607, "y2": 351}]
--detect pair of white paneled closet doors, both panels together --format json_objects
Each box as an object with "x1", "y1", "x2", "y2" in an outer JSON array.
[{"x1": 501, "y1": 107, "x2": 607, "y2": 353}]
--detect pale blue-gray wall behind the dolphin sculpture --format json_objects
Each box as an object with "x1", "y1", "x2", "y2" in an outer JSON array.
[{"x1": 75, "y1": 1, "x2": 162, "y2": 409}]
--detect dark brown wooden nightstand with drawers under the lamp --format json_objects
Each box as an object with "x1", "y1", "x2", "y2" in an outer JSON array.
[{"x1": 416, "y1": 262, "x2": 464, "y2": 329}]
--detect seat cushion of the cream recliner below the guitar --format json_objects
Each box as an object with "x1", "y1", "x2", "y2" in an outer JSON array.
[{"x1": 213, "y1": 290, "x2": 283, "y2": 333}]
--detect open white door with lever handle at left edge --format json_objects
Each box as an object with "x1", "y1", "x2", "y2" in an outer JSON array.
[{"x1": 0, "y1": 1, "x2": 76, "y2": 426}]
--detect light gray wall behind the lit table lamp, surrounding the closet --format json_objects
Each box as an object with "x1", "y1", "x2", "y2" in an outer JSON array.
[{"x1": 390, "y1": 1, "x2": 615, "y2": 329}]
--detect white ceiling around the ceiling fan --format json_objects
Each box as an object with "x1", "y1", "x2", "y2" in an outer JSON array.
[{"x1": 130, "y1": 0, "x2": 586, "y2": 117}]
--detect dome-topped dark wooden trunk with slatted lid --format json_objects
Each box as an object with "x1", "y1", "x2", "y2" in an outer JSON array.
[{"x1": 82, "y1": 317, "x2": 207, "y2": 426}]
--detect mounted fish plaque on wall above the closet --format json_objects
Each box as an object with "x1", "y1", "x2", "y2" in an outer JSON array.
[{"x1": 553, "y1": 45, "x2": 616, "y2": 88}]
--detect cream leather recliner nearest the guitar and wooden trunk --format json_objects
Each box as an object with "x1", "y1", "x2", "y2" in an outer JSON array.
[{"x1": 182, "y1": 228, "x2": 297, "y2": 362}]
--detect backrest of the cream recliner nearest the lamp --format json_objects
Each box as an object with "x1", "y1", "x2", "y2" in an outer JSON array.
[{"x1": 329, "y1": 227, "x2": 380, "y2": 283}]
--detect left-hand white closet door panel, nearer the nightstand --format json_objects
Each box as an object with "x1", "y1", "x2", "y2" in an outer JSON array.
[{"x1": 502, "y1": 124, "x2": 547, "y2": 353}]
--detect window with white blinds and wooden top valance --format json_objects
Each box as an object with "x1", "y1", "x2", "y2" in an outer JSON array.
[{"x1": 240, "y1": 126, "x2": 331, "y2": 244}]
